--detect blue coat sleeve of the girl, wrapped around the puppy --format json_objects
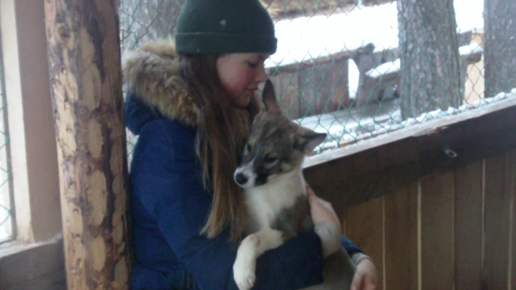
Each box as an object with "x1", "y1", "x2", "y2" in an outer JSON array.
[{"x1": 133, "y1": 123, "x2": 323, "y2": 289}]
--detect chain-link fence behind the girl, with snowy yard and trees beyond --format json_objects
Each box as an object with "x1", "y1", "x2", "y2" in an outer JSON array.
[{"x1": 120, "y1": 0, "x2": 516, "y2": 156}]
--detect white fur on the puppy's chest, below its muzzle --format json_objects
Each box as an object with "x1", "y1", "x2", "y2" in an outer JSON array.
[{"x1": 245, "y1": 169, "x2": 306, "y2": 233}]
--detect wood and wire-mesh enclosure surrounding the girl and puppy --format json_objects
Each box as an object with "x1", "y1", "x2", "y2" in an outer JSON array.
[{"x1": 0, "y1": 0, "x2": 516, "y2": 290}]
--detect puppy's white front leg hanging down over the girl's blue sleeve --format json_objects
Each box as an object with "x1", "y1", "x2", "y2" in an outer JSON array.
[{"x1": 233, "y1": 228, "x2": 283, "y2": 290}]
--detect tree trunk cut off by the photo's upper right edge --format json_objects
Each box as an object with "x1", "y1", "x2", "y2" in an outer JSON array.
[{"x1": 484, "y1": 0, "x2": 516, "y2": 97}]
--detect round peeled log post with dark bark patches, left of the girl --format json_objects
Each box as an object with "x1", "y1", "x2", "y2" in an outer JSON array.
[{"x1": 45, "y1": 0, "x2": 131, "y2": 290}]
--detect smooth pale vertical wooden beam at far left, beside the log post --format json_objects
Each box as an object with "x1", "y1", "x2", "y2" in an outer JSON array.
[{"x1": 0, "y1": 0, "x2": 62, "y2": 243}]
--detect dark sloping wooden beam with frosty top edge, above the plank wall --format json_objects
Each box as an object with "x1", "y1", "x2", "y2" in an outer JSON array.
[{"x1": 304, "y1": 99, "x2": 516, "y2": 212}]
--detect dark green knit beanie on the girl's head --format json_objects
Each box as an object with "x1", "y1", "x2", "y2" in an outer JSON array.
[{"x1": 175, "y1": 0, "x2": 277, "y2": 54}]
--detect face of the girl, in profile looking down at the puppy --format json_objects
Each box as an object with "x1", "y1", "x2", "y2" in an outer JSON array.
[{"x1": 217, "y1": 53, "x2": 269, "y2": 108}]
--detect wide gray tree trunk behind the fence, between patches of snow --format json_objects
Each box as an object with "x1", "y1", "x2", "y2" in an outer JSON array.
[{"x1": 398, "y1": 0, "x2": 462, "y2": 119}]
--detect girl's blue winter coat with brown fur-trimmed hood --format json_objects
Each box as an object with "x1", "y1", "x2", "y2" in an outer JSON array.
[{"x1": 124, "y1": 39, "x2": 360, "y2": 290}]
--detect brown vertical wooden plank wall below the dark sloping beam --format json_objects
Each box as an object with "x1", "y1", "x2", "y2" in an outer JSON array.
[{"x1": 341, "y1": 151, "x2": 516, "y2": 290}]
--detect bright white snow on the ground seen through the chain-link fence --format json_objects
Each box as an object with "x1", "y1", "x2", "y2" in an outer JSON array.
[{"x1": 265, "y1": 0, "x2": 484, "y2": 98}]
